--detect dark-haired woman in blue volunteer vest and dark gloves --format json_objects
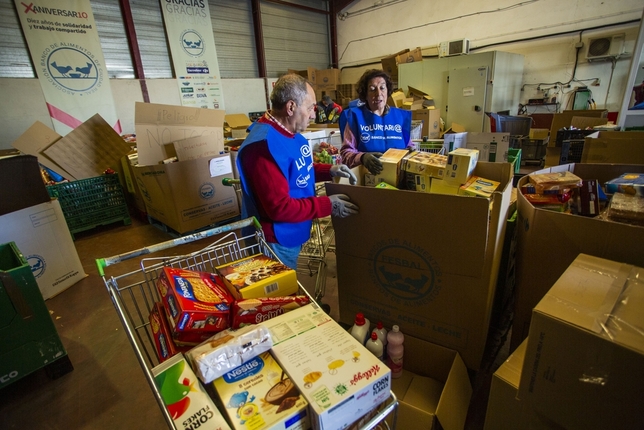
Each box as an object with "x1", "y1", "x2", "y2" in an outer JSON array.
[{"x1": 340, "y1": 69, "x2": 412, "y2": 175}]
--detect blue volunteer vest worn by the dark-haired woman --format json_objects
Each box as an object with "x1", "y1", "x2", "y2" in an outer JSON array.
[{"x1": 340, "y1": 105, "x2": 411, "y2": 153}]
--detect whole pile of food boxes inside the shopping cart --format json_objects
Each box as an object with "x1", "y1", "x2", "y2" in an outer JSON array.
[{"x1": 150, "y1": 254, "x2": 390, "y2": 430}]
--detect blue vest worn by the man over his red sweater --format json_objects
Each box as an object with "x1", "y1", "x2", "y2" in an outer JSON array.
[{"x1": 237, "y1": 122, "x2": 315, "y2": 247}]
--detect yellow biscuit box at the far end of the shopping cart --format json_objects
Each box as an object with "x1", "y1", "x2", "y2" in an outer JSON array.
[{"x1": 216, "y1": 254, "x2": 299, "y2": 300}]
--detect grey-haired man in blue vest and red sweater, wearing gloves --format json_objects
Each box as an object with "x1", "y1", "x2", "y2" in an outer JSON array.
[{"x1": 237, "y1": 74, "x2": 358, "y2": 269}]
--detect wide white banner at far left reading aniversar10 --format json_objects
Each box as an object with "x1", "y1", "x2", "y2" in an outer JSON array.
[{"x1": 14, "y1": 0, "x2": 122, "y2": 136}]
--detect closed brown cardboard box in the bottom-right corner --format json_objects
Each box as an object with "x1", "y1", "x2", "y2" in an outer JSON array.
[{"x1": 518, "y1": 254, "x2": 644, "y2": 430}]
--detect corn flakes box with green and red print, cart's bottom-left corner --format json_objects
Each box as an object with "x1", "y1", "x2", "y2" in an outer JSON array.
[{"x1": 152, "y1": 353, "x2": 230, "y2": 430}]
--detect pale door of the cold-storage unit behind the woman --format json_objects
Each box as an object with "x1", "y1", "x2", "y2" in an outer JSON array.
[{"x1": 445, "y1": 66, "x2": 489, "y2": 132}]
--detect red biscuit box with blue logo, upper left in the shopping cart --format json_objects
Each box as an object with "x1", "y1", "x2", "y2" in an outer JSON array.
[{"x1": 156, "y1": 267, "x2": 235, "y2": 334}]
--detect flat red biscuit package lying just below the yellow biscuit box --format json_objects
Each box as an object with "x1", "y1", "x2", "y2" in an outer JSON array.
[{"x1": 231, "y1": 296, "x2": 310, "y2": 328}]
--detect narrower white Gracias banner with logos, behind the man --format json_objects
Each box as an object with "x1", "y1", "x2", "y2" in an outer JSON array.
[{"x1": 160, "y1": 0, "x2": 225, "y2": 110}]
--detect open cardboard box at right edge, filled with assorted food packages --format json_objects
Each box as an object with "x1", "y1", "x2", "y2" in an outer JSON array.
[{"x1": 510, "y1": 164, "x2": 644, "y2": 350}]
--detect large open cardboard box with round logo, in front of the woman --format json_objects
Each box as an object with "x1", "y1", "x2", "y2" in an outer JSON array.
[{"x1": 326, "y1": 162, "x2": 513, "y2": 370}]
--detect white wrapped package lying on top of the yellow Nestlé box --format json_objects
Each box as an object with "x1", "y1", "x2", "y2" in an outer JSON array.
[{"x1": 186, "y1": 324, "x2": 273, "y2": 384}]
